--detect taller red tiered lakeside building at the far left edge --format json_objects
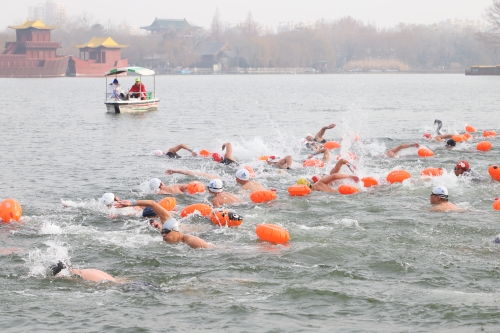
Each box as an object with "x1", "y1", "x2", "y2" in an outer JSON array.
[{"x1": 0, "y1": 21, "x2": 68, "y2": 77}]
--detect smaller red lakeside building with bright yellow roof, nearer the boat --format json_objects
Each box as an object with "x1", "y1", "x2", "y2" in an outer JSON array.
[{"x1": 68, "y1": 37, "x2": 128, "y2": 76}]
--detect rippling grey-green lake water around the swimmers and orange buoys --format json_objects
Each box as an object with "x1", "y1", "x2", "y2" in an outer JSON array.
[{"x1": 0, "y1": 74, "x2": 500, "y2": 332}]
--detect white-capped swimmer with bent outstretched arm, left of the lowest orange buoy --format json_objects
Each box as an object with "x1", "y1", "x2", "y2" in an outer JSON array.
[{"x1": 116, "y1": 200, "x2": 212, "y2": 249}]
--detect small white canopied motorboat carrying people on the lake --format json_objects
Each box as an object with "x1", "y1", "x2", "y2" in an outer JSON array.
[{"x1": 104, "y1": 66, "x2": 160, "y2": 113}]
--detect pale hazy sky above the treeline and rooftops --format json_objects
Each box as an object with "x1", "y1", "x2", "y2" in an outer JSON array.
[{"x1": 0, "y1": 0, "x2": 492, "y2": 30}]
